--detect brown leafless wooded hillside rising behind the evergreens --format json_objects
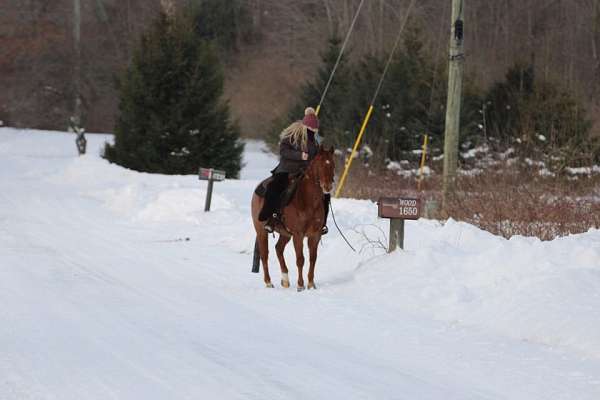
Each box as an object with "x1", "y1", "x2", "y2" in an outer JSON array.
[{"x1": 0, "y1": 0, "x2": 600, "y2": 130}]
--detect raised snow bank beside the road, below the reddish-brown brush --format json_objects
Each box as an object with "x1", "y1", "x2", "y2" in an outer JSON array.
[{"x1": 352, "y1": 221, "x2": 600, "y2": 357}]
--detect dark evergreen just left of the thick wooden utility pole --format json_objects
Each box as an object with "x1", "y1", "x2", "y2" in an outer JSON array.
[{"x1": 356, "y1": 27, "x2": 443, "y2": 161}]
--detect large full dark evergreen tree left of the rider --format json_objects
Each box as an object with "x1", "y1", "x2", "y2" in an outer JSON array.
[{"x1": 105, "y1": 14, "x2": 243, "y2": 177}]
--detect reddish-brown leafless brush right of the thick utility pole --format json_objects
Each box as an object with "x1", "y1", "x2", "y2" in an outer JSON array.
[{"x1": 444, "y1": 170, "x2": 600, "y2": 240}]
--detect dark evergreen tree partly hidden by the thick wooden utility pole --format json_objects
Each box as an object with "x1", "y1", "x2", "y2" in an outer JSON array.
[{"x1": 363, "y1": 26, "x2": 479, "y2": 160}]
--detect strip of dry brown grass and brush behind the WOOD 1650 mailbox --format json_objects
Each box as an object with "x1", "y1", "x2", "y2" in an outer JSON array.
[{"x1": 344, "y1": 160, "x2": 600, "y2": 240}]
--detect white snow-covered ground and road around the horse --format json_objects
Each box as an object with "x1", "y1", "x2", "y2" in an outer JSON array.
[{"x1": 0, "y1": 128, "x2": 600, "y2": 400}]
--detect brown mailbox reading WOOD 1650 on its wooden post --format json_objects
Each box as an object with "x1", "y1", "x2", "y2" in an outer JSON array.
[{"x1": 377, "y1": 197, "x2": 421, "y2": 253}]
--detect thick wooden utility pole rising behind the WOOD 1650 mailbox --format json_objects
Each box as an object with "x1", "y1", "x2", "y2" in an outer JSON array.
[{"x1": 443, "y1": 0, "x2": 465, "y2": 209}]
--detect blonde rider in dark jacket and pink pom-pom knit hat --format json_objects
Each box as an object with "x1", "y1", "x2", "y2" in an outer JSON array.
[{"x1": 258, "y1": 107, "x2": 331, "y2": 235}]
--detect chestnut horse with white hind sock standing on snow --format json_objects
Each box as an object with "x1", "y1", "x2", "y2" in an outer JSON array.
[{"x1": 252, "y1": 147, "x2": 335, "y2": 291}]
